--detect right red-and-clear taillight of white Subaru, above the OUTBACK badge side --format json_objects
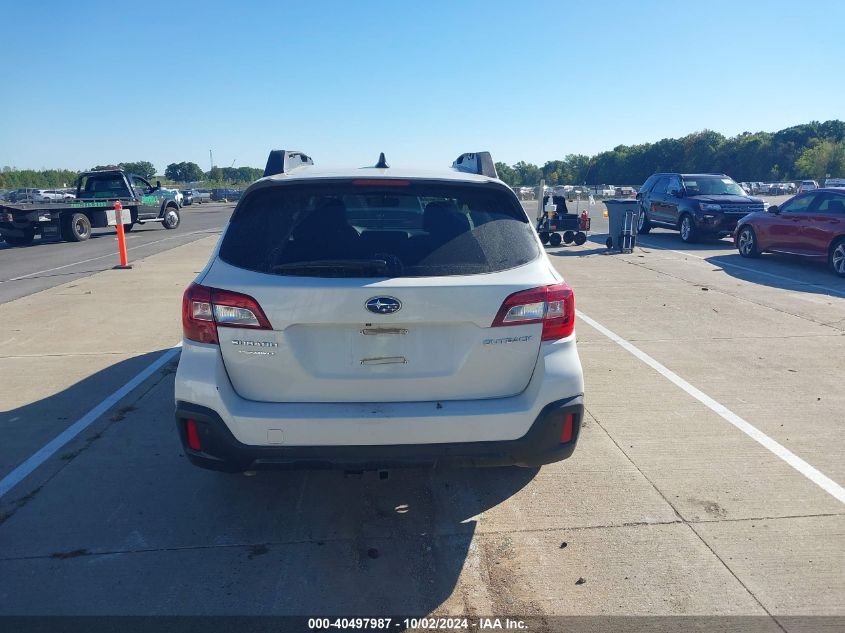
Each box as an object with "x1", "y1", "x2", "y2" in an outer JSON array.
[{"x1": 491, "y1": 284, "x2": 575, "y2": 341}]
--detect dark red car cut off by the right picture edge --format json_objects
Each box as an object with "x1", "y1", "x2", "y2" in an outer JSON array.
[{"x1": 734, "y1": 188, "x2": 845, "y2": 277}]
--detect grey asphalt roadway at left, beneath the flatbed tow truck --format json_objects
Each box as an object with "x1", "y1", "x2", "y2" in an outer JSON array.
[{"x1": 0, "y1": 202, "x2": 234, "y2": 303}]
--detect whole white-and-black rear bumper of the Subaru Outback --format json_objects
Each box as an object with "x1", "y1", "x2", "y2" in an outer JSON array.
[{"x1": 175, "y1": 335, "x2": 584, "y2": 470}]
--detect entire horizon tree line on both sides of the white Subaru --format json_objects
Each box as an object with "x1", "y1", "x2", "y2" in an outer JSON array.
[{"x1": 6, "y1": 120, "x2": 845, "y2": 189}]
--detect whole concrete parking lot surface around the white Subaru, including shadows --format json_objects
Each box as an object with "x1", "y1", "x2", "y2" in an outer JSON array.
[{"x1": 0, "y1": 203, "x2": 845, "y2": 631}]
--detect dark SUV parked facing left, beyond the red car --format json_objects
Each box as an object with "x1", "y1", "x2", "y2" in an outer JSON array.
[{"x1": 637, "y1": 174, "x2": 764, "y2": 243}]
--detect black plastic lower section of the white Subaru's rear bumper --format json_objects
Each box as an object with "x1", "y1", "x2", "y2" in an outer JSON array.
[{"x1": 171, "y1": 396, "x2": 584, "y2": 472}]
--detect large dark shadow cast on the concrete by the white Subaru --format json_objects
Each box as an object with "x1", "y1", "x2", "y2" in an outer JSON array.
[{"x1": 0, "y1": 350, "x2": 539, "y2": 616}]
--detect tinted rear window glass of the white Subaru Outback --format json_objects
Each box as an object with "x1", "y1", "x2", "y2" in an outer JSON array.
[{"x1": 220, "y1": 181, "x2": 539, "y2": 277}]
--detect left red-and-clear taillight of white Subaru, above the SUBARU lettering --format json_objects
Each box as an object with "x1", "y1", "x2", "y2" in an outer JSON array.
[{"x1": 182, "y1": 284, "x2": 273, "y2": 344}]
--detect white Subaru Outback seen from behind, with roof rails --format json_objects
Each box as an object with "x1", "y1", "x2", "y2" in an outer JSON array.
[{"x1": 176, "y1": 150, "x2": 584, "y2": 472}]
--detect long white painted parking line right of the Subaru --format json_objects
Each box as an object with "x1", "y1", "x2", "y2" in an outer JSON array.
[{"x1": 576, "y1": 310, "x2": 845, "y2": 503}]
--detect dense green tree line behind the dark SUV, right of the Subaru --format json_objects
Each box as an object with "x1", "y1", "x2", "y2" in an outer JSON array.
[{"x1": 496, "y1": 120, "x2": 845, "y2": 186}]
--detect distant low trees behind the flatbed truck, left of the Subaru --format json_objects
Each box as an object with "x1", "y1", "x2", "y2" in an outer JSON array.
[{"x1": 0, "y1": 160, "x2": 264, "y2": 189}]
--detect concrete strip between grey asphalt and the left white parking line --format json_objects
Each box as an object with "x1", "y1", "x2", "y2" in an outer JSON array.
[{"x1": 0, "y1": 236, "x2": 217, "y2": 484}]
